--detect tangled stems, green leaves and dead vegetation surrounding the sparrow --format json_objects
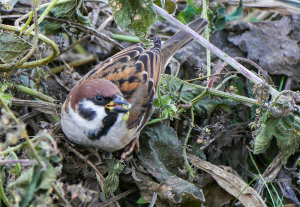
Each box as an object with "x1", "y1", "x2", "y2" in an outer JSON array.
[{"x1": 0, "y1": 0, "x2": 300, "y2": 206}]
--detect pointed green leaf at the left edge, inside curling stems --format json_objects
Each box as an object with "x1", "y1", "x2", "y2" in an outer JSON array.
[{"x1": 0, "y1": 31, "x2": 31, "y2": 63}]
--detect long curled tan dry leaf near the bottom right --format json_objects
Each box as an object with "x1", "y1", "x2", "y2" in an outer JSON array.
[{"x1": 187, "y1": 154, "x2": 267, "y2": 207}]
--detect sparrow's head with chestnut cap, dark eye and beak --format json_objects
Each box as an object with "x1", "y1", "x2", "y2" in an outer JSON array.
[{"x1": 70, "y1": 79, "x2": 130, "y2": 121}]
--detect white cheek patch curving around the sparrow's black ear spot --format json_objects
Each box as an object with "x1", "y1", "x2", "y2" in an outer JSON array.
[{"x1": 69, "y1": 100, "x2": 107, "y2": 131}]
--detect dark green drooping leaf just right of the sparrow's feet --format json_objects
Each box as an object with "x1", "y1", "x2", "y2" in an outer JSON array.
[{"x1": 139, "y1": 123, "x2": 183, "y2": 181}]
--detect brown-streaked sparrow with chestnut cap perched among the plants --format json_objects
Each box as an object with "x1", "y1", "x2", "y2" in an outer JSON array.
[{"x1": 61, "y1": 18, "x2": 207, "y2": 159}]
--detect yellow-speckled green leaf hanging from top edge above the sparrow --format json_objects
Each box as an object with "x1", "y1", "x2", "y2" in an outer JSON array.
[{"x1": 108, "y1": 0, "x2": 156, "y2": 37}]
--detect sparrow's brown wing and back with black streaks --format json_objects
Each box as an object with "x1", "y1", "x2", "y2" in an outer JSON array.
[{"x1": 79, "y1": 38, "x2": 161, "y2": 129}]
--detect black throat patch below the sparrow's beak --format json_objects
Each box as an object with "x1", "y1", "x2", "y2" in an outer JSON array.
[{"x1": 87, "y1": 110, "x2": 118, "y2": 140}]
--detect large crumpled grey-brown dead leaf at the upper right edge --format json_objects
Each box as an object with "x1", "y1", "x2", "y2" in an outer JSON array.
[{"x1": 228, "y1": 15, "x2": 300, "y2": 80}]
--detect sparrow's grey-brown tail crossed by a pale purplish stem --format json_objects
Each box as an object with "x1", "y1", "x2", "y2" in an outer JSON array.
[{"x1": 161, "y1": 18, "x2": 208, "y2": 72}]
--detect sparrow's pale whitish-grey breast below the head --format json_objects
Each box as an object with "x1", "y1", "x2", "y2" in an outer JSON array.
[{"x1": 61, "y1": 101, "x2": 137, "y2": 151}]
